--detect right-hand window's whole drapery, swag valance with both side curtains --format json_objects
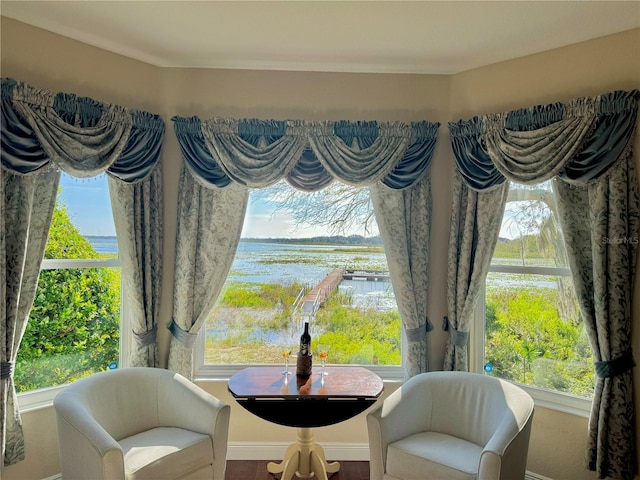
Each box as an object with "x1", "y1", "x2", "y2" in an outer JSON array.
[{"x1": 444, "y1": 90, "x2": 640, "y2": 480}]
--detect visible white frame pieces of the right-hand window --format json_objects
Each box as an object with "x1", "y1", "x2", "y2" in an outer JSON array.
[{"x1": 469, "y1": 264, "x2": 592, "y2": 418}]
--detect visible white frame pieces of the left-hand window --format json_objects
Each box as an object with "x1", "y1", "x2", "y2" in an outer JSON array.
[{"x1": 17, "y1": 256, "x2": 131, "y2": 413}]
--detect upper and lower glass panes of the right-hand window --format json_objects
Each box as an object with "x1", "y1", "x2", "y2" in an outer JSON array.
[{"x1": 484, "y1": 182, "x2": 594, "y2": 397}]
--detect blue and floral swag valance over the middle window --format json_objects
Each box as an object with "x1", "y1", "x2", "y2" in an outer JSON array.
[{"x1": 172, "y1": 116, "x2": 439, "y2": 191}]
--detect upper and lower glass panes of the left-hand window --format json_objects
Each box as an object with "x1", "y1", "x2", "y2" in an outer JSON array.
[{"x1": 15, "y1": 174, "x2": 121, "y2": 392}]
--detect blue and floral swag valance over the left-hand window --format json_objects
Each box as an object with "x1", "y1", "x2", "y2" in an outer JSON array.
[{"x1": 1, "y1": 78, "x2": 165, "y2": 183}]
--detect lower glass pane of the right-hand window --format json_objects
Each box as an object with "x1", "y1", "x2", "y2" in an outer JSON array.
[{"x1": 485, "y1": 273, "x2": 594, "y2": 397}]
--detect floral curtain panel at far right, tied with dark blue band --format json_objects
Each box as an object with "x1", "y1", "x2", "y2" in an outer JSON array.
[{"x1": 555, "y1": 156, "x2": 640, "y2": 480}]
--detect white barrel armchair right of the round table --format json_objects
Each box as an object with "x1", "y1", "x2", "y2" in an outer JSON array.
[{"x1": 367, "y1": 372, "x2": 534, "y2": 480}]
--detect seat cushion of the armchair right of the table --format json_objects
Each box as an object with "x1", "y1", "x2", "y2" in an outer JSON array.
[{"x1": 387, "y1": 432, "x2": 482, "y2": 480}]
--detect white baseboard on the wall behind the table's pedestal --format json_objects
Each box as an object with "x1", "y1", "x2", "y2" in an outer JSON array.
[{"x1": 227, "y1": 442, "x2": 369, "y2": 462}]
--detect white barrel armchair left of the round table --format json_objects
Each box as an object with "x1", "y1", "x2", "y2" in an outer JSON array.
[{"x1": 54, "y1": 368, "x2": 230, "y2": 480}]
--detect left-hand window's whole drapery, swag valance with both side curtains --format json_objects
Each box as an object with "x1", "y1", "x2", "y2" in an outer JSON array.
[{"x1": 0, "y1": 78, "x2": 165, "y2": 465}]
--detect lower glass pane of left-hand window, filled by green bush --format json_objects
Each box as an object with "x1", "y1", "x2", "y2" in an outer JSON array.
[{"x1": 15, "y1": 268, "x2": 120, "y2": 392}]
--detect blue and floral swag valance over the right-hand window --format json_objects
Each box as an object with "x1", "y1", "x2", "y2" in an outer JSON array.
[{"x1": 449, "y1": 90, "x2": 640, "y2": 190}]
